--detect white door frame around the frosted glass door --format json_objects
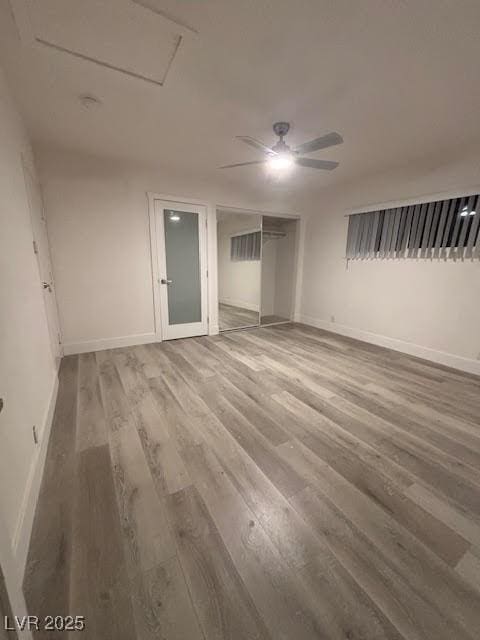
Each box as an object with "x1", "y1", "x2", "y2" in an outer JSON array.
[{"x1": 147, "y1": 191, "x2": 214, "y2": 342}]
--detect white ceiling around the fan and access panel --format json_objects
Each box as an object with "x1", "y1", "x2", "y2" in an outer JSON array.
[{"x1": 0, "y1": 0, "x2": 480, "y2": 205}]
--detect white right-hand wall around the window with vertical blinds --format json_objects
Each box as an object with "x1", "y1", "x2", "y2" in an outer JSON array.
[{"x1": 300, "y1": 155, "x2": 480, "y2": 373}]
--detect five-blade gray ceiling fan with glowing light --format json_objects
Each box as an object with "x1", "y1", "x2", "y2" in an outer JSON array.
[{"x1": 220, "y1": 122, "x2": 343, "y2": 171}]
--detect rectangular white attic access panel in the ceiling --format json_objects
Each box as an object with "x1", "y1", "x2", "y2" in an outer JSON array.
[{"x1": 11, "y1": 0, "x2": 194, "y2": 85}]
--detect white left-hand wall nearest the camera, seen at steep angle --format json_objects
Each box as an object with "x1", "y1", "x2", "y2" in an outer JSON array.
[{"x1": 0, "y1": 66, "x2": 57, "y2": 636}]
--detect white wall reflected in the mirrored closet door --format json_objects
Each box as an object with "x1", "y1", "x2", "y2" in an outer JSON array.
[{"x1": 217, "y1": 214, "x2": 262, "y2": 311}]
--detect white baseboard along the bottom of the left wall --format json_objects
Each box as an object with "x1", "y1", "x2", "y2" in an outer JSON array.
[{"x1": 12, "y1": 374, "x2": 58, "y2": 576}]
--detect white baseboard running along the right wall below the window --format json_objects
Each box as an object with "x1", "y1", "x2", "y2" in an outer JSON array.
[{"x1": 296, "y1": 314, "x2": 480, "y2": 376}]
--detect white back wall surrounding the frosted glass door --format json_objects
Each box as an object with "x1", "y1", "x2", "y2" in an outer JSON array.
[{"x1": 36, "y1": 149, "x2": 292, "y2": 353}]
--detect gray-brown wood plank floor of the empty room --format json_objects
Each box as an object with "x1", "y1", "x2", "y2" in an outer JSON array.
[{"x1": 24, "y1": 325, "x2": 480, "y2": 640}]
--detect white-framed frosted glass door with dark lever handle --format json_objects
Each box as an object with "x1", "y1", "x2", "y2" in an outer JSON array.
[{"x1": 156, "y1": 201, "x2": 207, "y2": 340}]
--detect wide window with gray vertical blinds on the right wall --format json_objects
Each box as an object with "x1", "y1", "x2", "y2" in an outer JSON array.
[{"x1": 347, "y1": 195, "x2": 480, "y2": 260}]
